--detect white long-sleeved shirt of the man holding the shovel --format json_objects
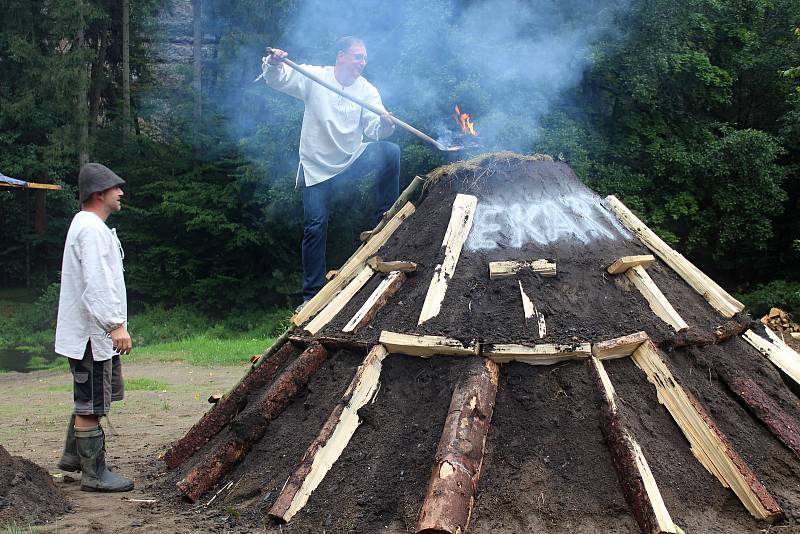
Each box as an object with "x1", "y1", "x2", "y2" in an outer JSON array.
[{"x1": 263, "y1": 61, "x2": 394, "y2": 186}]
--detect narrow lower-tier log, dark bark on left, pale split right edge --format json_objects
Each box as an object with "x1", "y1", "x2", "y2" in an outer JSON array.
[{"x1": 589, "y1": 356, "x2": 677, "y2": 534}]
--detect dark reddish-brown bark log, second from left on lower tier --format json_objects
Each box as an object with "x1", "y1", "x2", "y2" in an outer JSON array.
[{"x1": 177, "y1": 343, "x2": 328, "y2": 502}]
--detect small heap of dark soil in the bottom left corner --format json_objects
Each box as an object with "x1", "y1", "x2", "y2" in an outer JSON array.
[{"x1": 0, "y1": 445, "x2": 70, "y2": 532}]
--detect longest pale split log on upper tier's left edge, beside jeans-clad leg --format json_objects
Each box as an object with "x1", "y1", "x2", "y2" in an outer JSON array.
[{"x1": 292, "y1": 202, "x2": 415, "y2": 326}]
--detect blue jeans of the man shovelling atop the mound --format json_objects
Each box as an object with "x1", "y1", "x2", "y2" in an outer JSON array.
[{"x1": 303, "y1": 141, "x2": 400, "y2": 301}]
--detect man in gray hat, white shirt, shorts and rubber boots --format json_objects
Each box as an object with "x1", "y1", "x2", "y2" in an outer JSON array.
[{"x1": 56, "y1": 163, "x2": 133, "y2": 491}]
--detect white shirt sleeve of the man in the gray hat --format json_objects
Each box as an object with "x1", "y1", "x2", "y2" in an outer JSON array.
[{"x1": 76, "y1": 227, "x2": 127, "y2": 332}]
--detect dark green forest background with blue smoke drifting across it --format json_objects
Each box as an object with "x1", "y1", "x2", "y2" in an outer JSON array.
[{"x1": 0, "y1": 0, "x2": 800, "y2": 364}]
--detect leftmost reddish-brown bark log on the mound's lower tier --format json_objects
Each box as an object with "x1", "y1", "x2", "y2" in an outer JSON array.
[{"x1": 162, "y1": 343, "x2": 297, "y2": 469}]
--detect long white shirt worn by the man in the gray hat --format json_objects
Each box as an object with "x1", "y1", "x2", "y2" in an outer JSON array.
[{"x1": 56, "y1": 211, "x2": 128, "y2": 361}]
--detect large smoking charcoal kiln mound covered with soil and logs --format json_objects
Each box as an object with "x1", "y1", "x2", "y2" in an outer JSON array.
[{"x1": 151, "y1": 153, "x2": 800, "y2": 533}]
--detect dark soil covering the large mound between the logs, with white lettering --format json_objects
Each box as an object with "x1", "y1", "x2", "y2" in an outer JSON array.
[{"x1": 150, "y1": 154, "x2": 800, "y2": 533}]
